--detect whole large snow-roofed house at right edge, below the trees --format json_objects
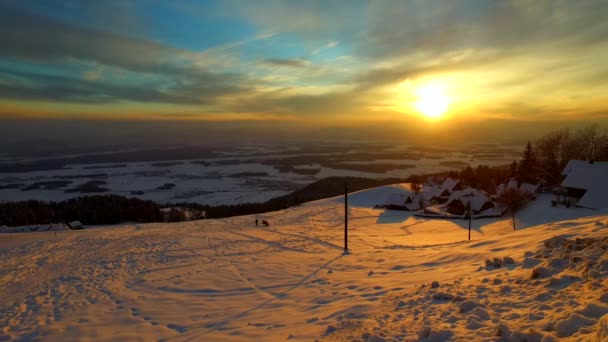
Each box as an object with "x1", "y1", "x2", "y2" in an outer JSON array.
[{"x1": 561, "y1": 160, "x2": 608, "y2": 209}]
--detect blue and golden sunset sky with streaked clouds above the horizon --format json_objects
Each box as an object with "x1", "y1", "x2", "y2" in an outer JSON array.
[{"x1": 0, "y1": 0, "x2": 608, "y2": 138}]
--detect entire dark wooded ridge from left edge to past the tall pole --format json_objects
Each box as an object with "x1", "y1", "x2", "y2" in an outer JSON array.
[{"x1": 0, "y1": 177, "x2": 414, "y2": 227}]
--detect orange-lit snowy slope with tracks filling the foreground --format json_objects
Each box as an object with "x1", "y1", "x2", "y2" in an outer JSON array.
[{"x1": 0, "y1": 185, "x2": 608, "y2": 341}]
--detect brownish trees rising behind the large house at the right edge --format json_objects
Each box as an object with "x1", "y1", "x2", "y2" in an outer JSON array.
[{"x1": 510, "y1": 124, "x2": 608, "y2": 185}]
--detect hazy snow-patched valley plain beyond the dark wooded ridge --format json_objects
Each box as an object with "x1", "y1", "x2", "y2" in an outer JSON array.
[{"x1": 0, "y1": 142, "x2": 521, "y2": 204}]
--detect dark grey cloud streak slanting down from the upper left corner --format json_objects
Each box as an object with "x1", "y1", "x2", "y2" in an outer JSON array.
[{"x1": 0, "y1": 3, "x2": 249, "y2": 83}]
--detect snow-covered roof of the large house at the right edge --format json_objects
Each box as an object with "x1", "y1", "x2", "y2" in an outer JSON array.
[{"x1": 561, "y1": 167, "x2": 608, "y2": 209}]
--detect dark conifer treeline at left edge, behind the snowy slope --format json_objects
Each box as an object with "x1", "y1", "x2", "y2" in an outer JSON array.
[{"x1": 0, "y1": 195, "x2": 163, "y2": 227}]
